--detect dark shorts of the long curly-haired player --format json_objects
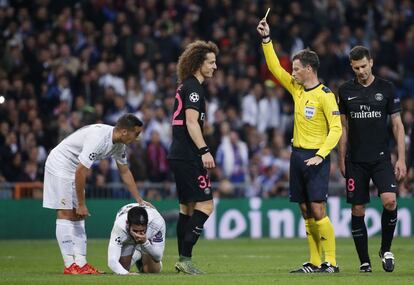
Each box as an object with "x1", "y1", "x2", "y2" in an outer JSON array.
[{"x1": 168, "y1": 159, "x2": 213, "y2": 204}]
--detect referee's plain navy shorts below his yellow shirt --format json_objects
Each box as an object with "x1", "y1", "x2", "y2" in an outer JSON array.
[{"x1": 289, "y1": 148, "x2": 331, "y2": 203}]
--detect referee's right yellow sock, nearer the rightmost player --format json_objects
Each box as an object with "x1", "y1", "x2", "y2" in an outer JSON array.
[{"x1": 316, "y1": 216, "x2": 336, "y2": 266}]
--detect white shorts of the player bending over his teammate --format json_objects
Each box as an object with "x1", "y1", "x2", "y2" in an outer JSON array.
[{"x1": 43, "y1": 168, "x2": 78, "y2": 210}]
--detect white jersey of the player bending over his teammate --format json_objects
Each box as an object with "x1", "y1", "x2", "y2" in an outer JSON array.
[{"x1": 46, "y1": 124, "x2": 128, "y2": 179}]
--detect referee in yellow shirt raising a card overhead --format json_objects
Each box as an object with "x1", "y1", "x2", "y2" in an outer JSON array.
[{"x1": 257, "y1": 19, "x2": 342, "y2": 273}]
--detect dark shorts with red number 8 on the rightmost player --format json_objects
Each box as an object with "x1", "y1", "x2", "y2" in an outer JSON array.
[{"x1": 345, "y1": 160, "x2": 398, "y2": 205}]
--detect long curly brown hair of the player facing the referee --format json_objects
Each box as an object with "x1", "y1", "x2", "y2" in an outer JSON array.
[{"x1": 177, "y1": 40, "x2": 219, "y2": 82}]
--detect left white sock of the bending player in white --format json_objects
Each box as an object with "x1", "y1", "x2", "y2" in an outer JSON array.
[{"x1": 56, "y1": 219, "x2": 75, "y2": 267}]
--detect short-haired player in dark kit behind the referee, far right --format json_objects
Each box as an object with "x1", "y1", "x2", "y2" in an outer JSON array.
[{"x1": 339, "y1": 46, "x2": 407, "y2": 272}]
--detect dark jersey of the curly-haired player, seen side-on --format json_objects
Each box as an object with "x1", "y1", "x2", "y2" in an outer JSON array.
[{"x1": 168, "y1": 76, "x2": 206, "y2": 160}]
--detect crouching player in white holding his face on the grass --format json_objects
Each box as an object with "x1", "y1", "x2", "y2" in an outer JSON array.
[{"x1": 108, "y1": 203, "x2": 165, "y2": 274}]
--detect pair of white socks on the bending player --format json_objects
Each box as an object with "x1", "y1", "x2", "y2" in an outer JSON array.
[{"x1": 56, "y1": 219, "x2": 87, "y2": 267}]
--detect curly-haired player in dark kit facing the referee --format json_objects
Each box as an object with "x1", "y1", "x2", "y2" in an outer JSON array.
[{"x1": 168, "y1": 41, "x2": 218, "y2": 274}]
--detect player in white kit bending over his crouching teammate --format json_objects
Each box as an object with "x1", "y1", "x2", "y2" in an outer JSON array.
[{"x1": 43, "y1": 114, "x2": 147, "y2": 274}]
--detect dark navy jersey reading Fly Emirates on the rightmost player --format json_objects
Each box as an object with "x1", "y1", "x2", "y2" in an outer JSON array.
[{"x1": 338, "y1": 77, "x2": 401, "y2": 162}]
